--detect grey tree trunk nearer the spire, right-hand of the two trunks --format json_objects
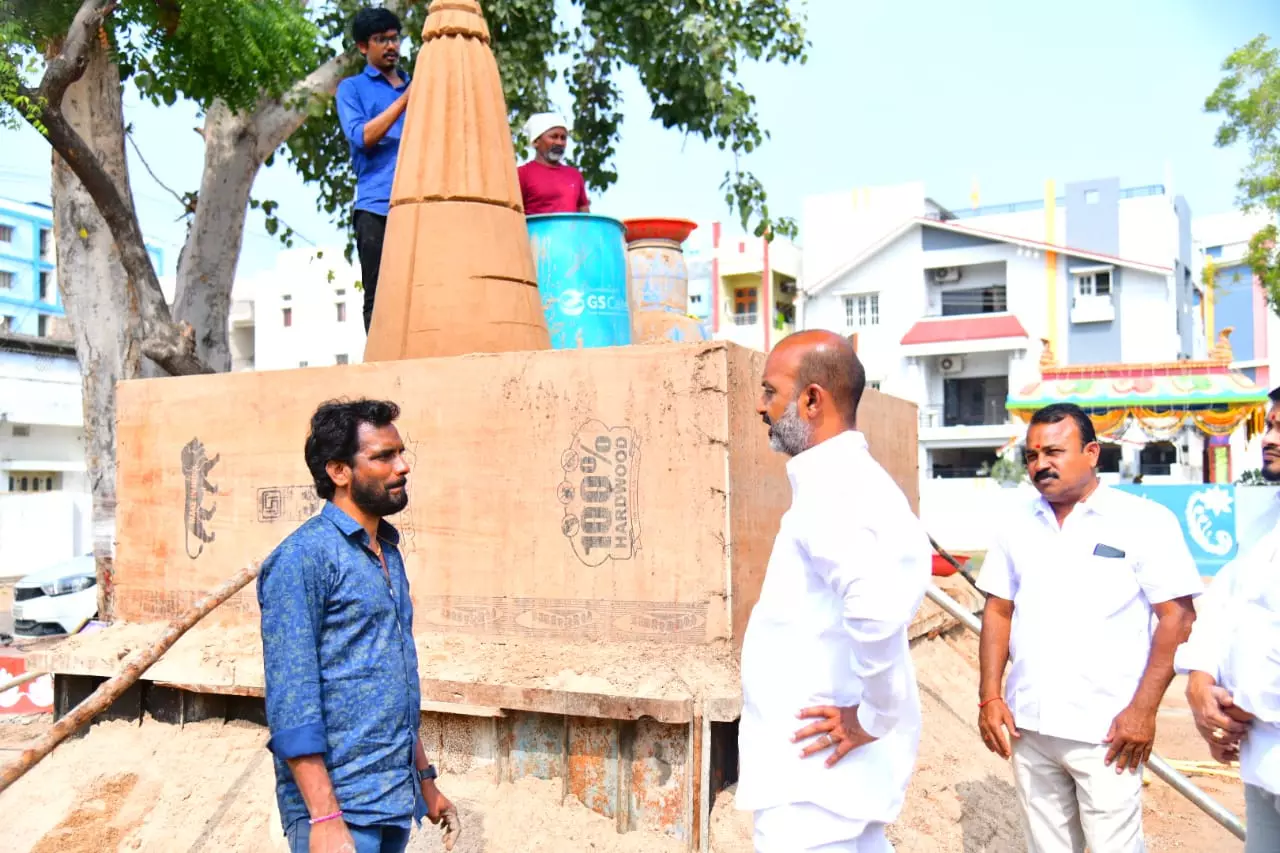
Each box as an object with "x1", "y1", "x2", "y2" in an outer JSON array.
[{"x1": 173, "y1": 101, "x2": 259, "y2": 373}]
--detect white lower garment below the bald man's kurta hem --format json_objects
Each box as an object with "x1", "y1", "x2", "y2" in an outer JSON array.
[{"x1": 754, "y1": 803, "x2": 893, "y2": 853}]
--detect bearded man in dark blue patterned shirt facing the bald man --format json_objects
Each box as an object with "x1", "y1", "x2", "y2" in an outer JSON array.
[{"x1": 257, "y1": 400, "x2": 461, "y2": 853}]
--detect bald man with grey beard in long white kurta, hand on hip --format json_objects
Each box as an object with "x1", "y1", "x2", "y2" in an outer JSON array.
[{"x1": 736, "y1": 332, "x2": 931, "y2": 853}]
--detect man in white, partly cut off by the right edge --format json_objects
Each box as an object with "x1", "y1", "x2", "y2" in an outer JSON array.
[{"x1": 1175, "y1": 388, "x2": 1280, "y2": 853}]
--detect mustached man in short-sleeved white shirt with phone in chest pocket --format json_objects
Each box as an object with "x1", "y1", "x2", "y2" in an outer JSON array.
[{"x1": 978, "y1": 403, "x2": 1202, "y2": 853}]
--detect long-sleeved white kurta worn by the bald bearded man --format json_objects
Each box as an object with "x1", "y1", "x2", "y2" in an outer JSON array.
[{"x1": 736, "y1": 432, "x2": 932, "y2": 824}]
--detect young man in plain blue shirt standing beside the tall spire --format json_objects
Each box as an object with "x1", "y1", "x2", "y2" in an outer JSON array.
[{"x1": 338, "y1": 8, "x2": 410, "y2": 333}]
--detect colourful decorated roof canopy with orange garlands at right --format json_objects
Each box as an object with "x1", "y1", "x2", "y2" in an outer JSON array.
[{"x1": 1006, "y1": 329, "x2": 1267, "y2": 441}]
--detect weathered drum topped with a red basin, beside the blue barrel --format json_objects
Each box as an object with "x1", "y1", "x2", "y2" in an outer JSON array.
[{"x1": 625, "y1": 219, "x2": 710, "y2": 343}]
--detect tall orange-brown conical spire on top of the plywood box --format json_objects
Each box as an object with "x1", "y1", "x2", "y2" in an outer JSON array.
[{"x1": 365, "y1": 0, "x2": 550, "y2": 361}]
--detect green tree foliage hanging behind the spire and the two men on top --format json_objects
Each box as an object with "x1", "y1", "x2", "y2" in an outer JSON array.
[{"x1": 287, "y1": 0, "x2": 809, "y2": 247}]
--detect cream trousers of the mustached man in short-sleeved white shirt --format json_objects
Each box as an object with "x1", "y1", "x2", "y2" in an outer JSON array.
[{"x1": 1012, "y1": 729, "x2": 1147, "y2": 853}]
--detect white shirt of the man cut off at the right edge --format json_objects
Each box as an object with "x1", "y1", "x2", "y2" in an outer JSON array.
[{"x1": 1174, "y1": 529, "x2": 1280, "y2": 794}]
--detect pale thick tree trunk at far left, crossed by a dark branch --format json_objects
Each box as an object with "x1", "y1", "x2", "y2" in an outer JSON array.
[{"x1": 52, "y1": 36, "x2": 143, "y2": 619}]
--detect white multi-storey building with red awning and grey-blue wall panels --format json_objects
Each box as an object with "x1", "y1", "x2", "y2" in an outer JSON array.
[{"x1": 797, "y1": 178, "x2": 1206, "y2": 491}]
